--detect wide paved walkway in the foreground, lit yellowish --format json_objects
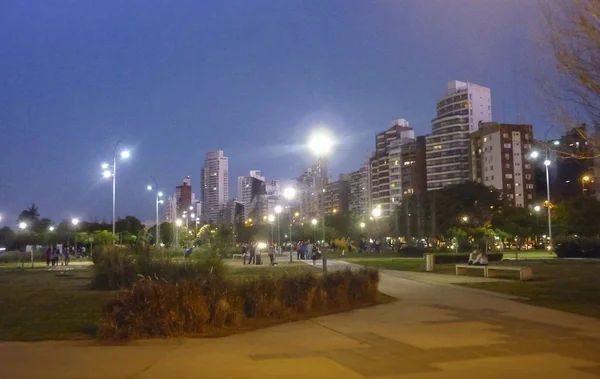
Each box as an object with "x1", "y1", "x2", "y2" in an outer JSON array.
[{"x1": 0, "y1": 262, "x2": 600, "y2": 379}]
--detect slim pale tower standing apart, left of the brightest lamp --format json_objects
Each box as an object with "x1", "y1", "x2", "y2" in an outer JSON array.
[{"x1": 202, "y1": 150, "x2": 229, "y2": 223}]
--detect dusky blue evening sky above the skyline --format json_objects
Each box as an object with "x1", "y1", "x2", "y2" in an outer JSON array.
[{"x1": 0, "y1": 0, "x2": 548, "y2": 227}]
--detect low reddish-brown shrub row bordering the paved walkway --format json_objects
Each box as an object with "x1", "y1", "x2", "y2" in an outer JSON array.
[{"x1": 99, "y1": 268, "x2": 379, "y2": 340}]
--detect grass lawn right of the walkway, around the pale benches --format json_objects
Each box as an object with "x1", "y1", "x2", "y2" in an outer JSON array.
[{"x1": 454, "y1": 259, "x2": 600, "y2": 318}]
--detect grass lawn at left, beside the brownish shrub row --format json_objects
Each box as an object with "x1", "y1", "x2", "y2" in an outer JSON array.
[{"x1": 0, "y1": 265, "x2": 112, "y2": 341}]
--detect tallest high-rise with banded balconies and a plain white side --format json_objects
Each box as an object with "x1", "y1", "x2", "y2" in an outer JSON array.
[{"x1": 426, "y1": 80, "x2": 492, "y2": 190}]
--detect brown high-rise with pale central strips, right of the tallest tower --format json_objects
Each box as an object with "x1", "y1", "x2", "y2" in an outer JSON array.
[{"x1": 470, "y1": 122, "x2": 535, "y2": 208}]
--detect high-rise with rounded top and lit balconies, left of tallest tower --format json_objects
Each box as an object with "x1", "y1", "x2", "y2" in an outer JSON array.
[{"x1": 370, "y1": 119, "x2": 415, "y2": 216}]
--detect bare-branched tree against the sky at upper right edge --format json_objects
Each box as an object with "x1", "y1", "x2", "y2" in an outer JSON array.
[{"x1": 542, "y1": 0, "x2": 600, "y2": 158}]
